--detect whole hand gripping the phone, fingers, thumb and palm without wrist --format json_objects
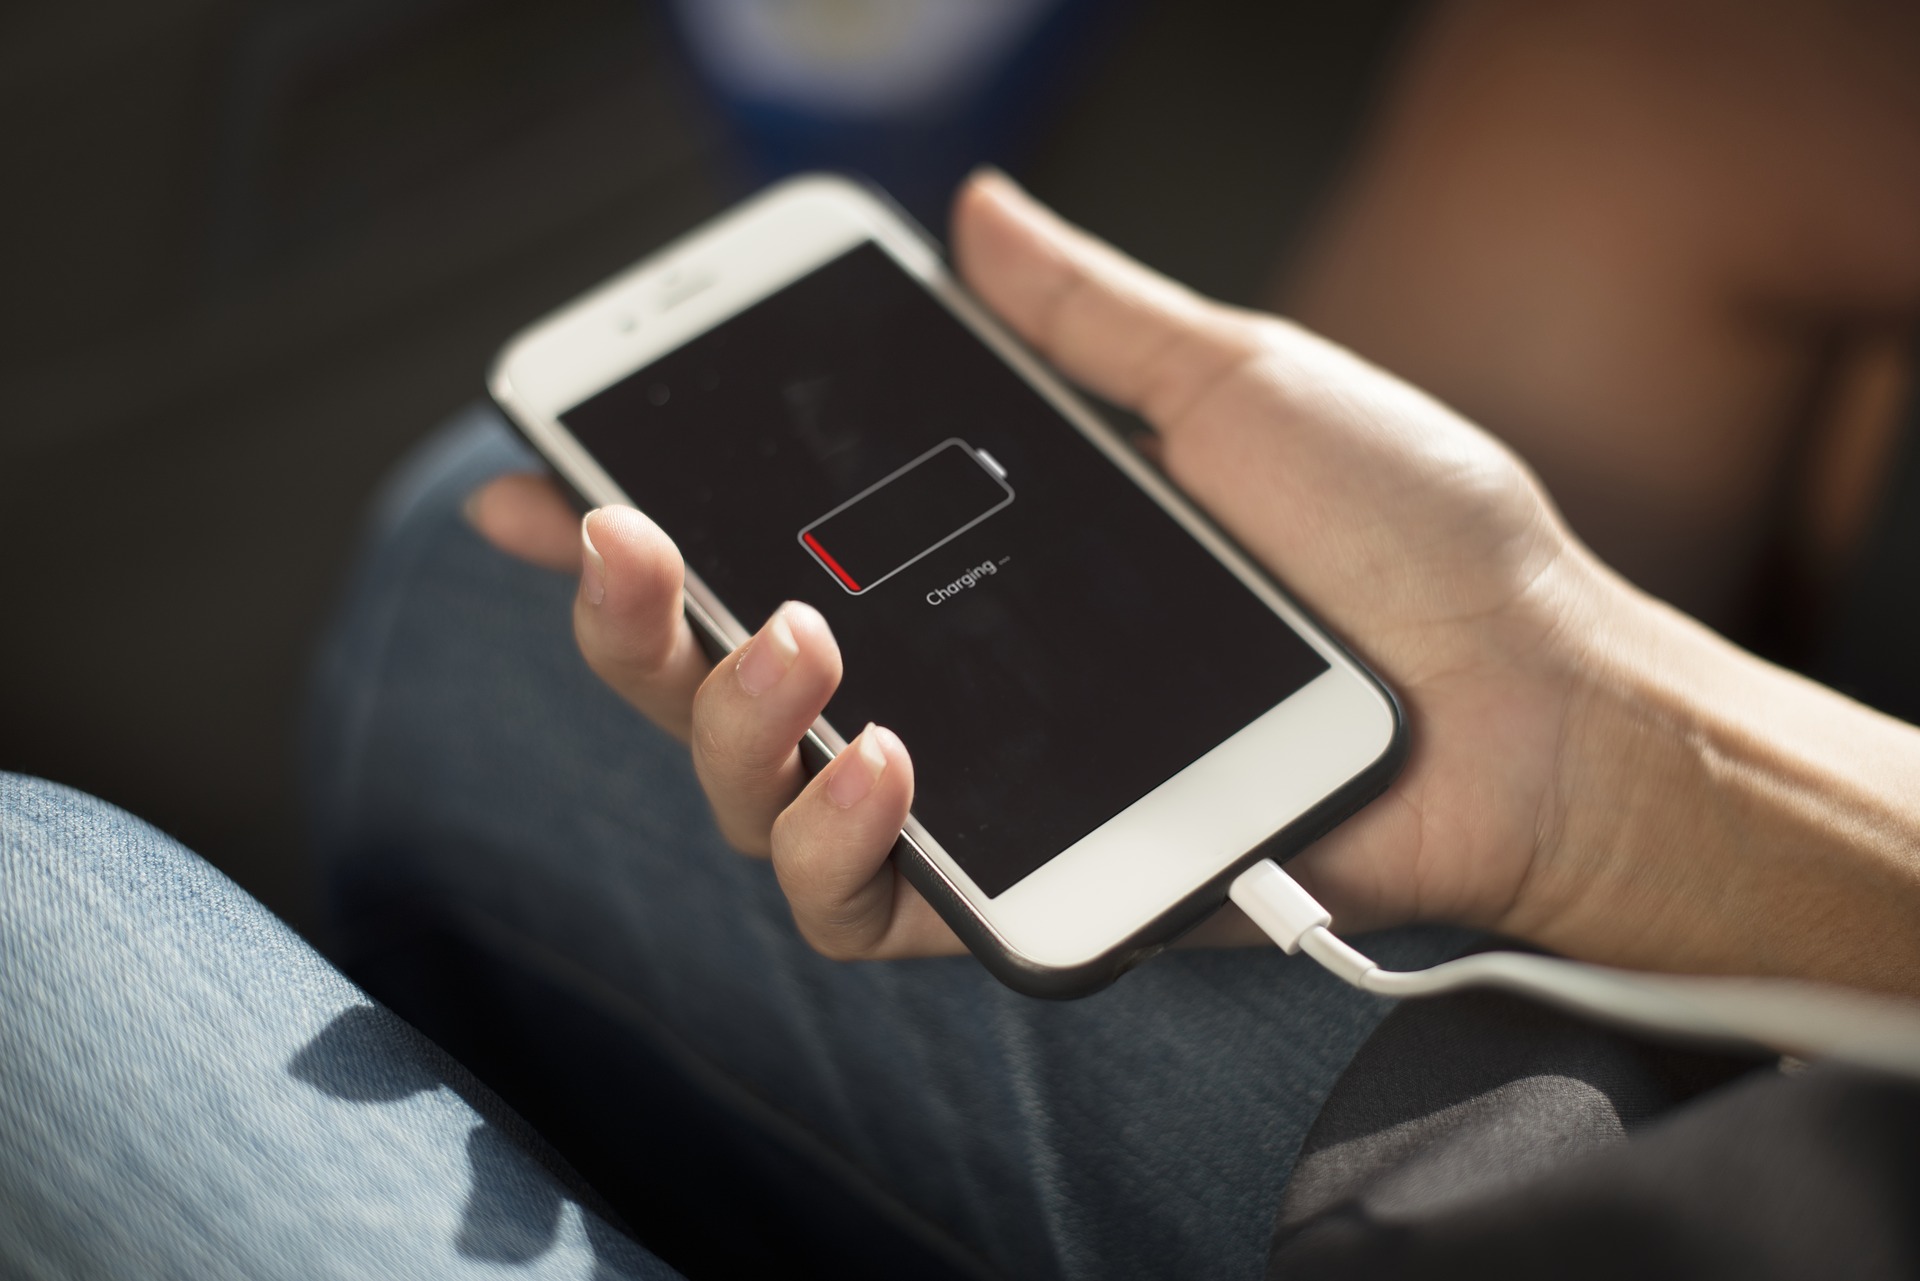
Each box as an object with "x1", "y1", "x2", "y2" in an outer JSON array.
[{"x1": 470, "y1": 177, "x2": 1586, "y2": 955}]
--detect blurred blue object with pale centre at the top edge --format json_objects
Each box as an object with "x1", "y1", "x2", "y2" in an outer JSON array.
[{"x1": 672, "y1": 0, "x2": 1131, "y2": 227}]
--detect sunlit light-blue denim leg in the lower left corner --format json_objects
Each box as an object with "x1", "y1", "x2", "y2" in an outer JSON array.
[{"x1": 0, "y1": 774, "x2": 674, "y2": 1281}]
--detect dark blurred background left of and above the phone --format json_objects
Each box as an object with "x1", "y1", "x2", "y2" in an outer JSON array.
[{"x1": 0, "y1": 0, "x2": 1413, "y2": 928}]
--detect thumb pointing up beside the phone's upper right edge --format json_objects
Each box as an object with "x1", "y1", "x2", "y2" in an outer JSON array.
[{"x1": 952, "y1": 169, "x2": 1258, "y2": 432}]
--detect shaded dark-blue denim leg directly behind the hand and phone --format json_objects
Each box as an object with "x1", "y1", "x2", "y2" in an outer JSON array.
[{"x1": 313, "y1": 409, "x2": 1461, "y2": 1279}]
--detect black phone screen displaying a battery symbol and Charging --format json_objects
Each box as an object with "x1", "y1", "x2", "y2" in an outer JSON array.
[{"x1": 561, "y1": 244, "x2": 1327, "y2": 897}]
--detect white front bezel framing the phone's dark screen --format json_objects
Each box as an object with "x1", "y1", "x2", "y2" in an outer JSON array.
[{"x1": 490, "y1": 175, "x2": 1402, "y2": 995}]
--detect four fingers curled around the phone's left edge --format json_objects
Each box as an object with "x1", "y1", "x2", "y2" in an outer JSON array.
[{"x1": 467, "y1": 485, "x2": 962, "y2": 958}]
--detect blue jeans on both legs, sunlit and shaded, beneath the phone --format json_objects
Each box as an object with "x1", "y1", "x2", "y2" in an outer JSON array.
[{"x1": 0, "y1": 411, "x2": 1459, "y2": 1277}]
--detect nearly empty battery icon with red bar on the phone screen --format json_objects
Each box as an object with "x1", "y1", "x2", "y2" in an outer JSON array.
[{"x1": 801, "y1": 438, "x2": 1014, "y2": 595}]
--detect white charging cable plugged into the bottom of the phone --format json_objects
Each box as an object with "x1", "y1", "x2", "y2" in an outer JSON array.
[{"x1": 1229, "y1": 858, "x2": 1920, "y2": 1079}]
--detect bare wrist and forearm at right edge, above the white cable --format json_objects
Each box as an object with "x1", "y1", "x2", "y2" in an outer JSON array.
[{"x1": 1501, "y1": 570, "x2": 1920, "y2": 995}]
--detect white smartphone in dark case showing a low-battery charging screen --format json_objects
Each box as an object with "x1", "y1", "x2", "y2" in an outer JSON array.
[{"x1": 492, "y1": 177, "x2": 1405, "y2": 997}]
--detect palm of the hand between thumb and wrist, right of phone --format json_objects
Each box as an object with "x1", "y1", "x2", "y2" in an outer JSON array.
[{"x1": 1164, "y1": 323, "x2": 1588, "y2": 926}]
